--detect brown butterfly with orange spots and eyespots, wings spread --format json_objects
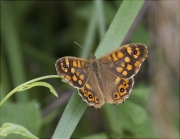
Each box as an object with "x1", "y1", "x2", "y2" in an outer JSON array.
[{"x1": 55, "y1": 43, "x2": 148, "y2": 108}]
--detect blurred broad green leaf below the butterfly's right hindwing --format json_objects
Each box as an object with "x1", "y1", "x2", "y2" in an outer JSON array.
[{"x1": 117, "y1": 100, "x2": 155, "y2": 138}]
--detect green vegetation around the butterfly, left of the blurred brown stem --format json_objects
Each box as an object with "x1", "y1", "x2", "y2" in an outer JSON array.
[{"x1": 0, "y1": 0, "x2": 178, "y2": 139}]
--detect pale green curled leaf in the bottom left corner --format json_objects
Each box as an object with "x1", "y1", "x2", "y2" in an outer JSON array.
[{"x1": 0, "y1": 123, "x2": 38, "y2": 139}]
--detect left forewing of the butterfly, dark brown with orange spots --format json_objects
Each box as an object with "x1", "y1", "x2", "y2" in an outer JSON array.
[{"x1": 55, "y1": 56, "x2": 90, "y2": 88}]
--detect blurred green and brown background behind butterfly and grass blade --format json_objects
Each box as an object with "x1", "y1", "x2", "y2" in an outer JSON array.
[{"x1": 0, "y1": 1, "x2": 180, "y2": 138}]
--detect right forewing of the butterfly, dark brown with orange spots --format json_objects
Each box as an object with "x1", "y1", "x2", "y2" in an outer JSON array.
[{"x1": 98, "y1": 43, "x2": 148, "y2": 79}]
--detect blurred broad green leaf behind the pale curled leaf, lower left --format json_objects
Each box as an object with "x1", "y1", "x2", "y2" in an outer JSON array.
[{"x1": 0, "y1": 101, "x2": 41, "y2": 138}]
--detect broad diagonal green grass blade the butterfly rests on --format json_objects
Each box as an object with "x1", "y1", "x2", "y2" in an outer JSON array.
[{"x1": 52, "y1": 0, "x2": 144, "y2": 139}]
